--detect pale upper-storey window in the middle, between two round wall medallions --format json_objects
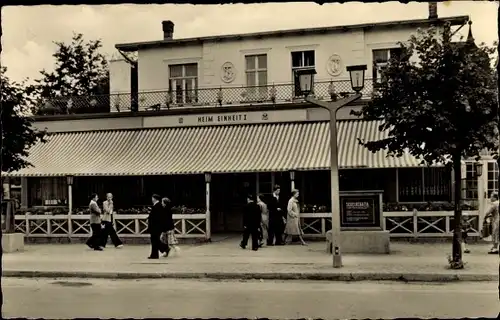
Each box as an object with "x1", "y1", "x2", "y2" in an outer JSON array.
[{"x1": 245, "y1": 54, "x2": 267, "y2": 101}]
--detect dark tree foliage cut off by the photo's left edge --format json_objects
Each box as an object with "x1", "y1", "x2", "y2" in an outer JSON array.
[{"x1": 0, "y1": 67, "x2": 46, "y2": 172}]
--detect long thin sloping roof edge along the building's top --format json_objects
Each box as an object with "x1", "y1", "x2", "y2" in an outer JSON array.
[{"x1": 115, "y1": 16, "x2": 469, "y2": 52}]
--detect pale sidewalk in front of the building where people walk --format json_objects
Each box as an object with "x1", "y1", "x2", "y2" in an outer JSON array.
[{"x1": 3, "y1": 238, "x2": 499, "y2": 281}]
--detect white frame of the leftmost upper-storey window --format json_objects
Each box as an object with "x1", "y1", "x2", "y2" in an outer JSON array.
[{"x1": 168, "y1": 62, "x2": 199, "y2": 104}]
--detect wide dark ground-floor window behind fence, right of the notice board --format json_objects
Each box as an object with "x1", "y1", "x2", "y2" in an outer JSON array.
[{"x1": 398, "y1": 168, "x2": 451, "y2": 202}]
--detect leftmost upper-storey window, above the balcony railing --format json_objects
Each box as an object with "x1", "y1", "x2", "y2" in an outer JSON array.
[{"x1": 169, "y1": 63, "x2": 198, "y2": 104}]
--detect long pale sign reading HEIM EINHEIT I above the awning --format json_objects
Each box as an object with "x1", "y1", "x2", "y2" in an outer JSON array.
[{"x1": 143, "y1": 109, "x2": 307, "y2": 128}]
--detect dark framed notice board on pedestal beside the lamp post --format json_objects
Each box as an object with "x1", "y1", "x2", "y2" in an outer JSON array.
[{"x1": 340, "y1": 191, "x2": 383, "y2": 230}]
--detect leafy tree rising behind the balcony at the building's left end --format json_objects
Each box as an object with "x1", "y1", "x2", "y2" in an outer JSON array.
[{"x1": 36, "y1": 33, "x2": 109, "y2": 114}]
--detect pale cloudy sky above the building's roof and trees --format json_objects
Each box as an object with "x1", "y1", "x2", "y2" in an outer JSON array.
[{"x1": 1, "y1": 1, "x2": 498, "y2": 81}]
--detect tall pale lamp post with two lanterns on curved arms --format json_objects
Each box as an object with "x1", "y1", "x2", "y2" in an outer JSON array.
[{"x1": 298, "y1": 65, "x2": 367, "y2": 268}]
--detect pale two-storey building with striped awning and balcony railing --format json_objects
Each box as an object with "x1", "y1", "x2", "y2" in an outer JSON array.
[{"x1": 3, "y1": 4, "x2": 486, "y2": 238}]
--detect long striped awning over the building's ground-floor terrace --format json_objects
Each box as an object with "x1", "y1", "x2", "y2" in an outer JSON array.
[{"x1": 5, "y1": 120, "x2": 430, "y2": 176}]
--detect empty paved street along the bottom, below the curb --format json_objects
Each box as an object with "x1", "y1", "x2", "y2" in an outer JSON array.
[{"x1": 2, "y1": 278, "x2": 500, "y2": 319}]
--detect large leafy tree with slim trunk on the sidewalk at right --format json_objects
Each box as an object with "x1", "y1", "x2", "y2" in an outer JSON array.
[{"x1": 355, "y1": 25, "x2": 498, "y2": 268}]
